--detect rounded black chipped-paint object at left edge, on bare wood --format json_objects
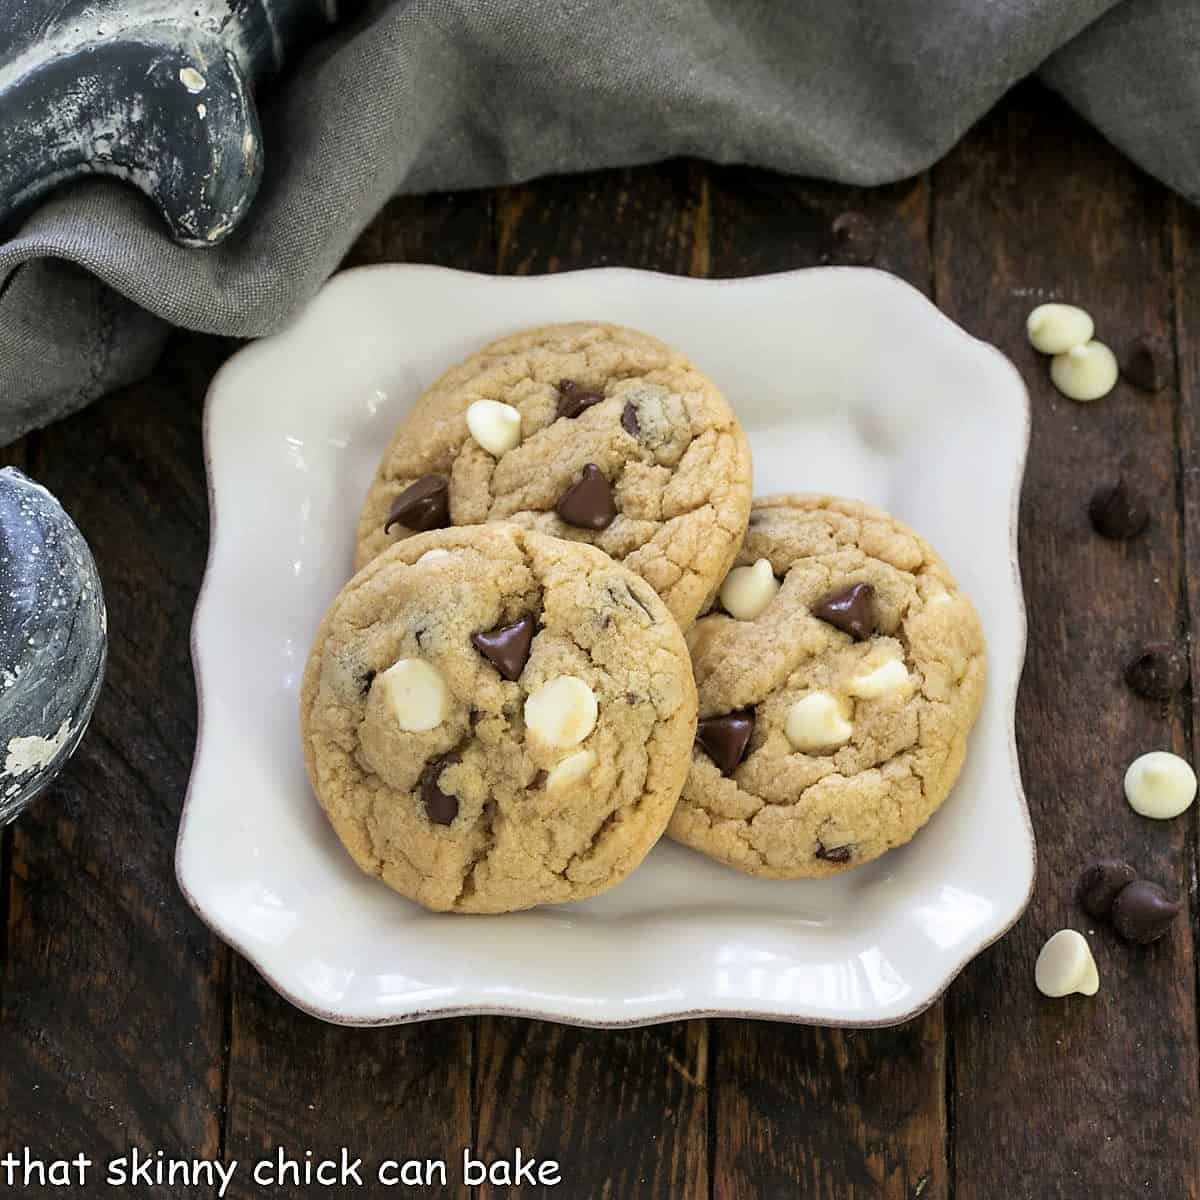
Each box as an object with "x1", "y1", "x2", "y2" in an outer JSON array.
[{"x1": 0, "y1": 467, "x2": 108, "y2": 824}]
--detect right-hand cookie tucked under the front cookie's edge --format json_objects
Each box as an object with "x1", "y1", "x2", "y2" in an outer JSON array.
[{"x1": 668, "y1": 496, "x2": 985, "y2": 878}]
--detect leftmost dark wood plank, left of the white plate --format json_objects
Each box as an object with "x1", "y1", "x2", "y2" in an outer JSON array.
[{"x1": 0, "y1": 335, "x2": 230, "y2": 1180}]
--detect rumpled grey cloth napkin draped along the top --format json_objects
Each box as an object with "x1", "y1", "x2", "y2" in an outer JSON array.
[{"x1": 0, "y1": 0, "x2": 1200, "y2": 443}]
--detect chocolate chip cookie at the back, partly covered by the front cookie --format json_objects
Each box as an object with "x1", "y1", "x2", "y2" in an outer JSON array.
[{"x1": 355, "y1": 322, "x2": 750, "y2": 628}]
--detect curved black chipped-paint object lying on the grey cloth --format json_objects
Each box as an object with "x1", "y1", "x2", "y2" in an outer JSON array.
[{"x1": 0, "y1": 0, "x2": 343, "y2": 246}]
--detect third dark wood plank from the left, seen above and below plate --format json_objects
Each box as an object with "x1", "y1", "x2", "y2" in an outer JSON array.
[{"x1": 476, "y1": 162, "x2": 709, "y2": 1200}]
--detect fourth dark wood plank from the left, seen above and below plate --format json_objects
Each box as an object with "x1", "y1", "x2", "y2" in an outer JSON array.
[{"x1": 709, "y1": 168, "x2": 947, "y2": 1200}]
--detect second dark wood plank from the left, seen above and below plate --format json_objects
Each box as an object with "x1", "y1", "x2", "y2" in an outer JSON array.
[{"x1": 226, "y1": 192, "x2": 494, "y2": 1198}]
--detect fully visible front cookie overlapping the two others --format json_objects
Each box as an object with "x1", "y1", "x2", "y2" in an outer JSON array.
[{"x1": 301, "y1": 523, "x2": 696, "y2": 912}]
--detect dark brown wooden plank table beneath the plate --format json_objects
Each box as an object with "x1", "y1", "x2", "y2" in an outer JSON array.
[{"x1": 0, "y1": 85, "x2": 1200, "y2": 1200}]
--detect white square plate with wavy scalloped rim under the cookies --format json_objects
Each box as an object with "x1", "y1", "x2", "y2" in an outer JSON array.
[{"x1": 178, "y1": 266, "x2": 1034, "y2": 1025}]
